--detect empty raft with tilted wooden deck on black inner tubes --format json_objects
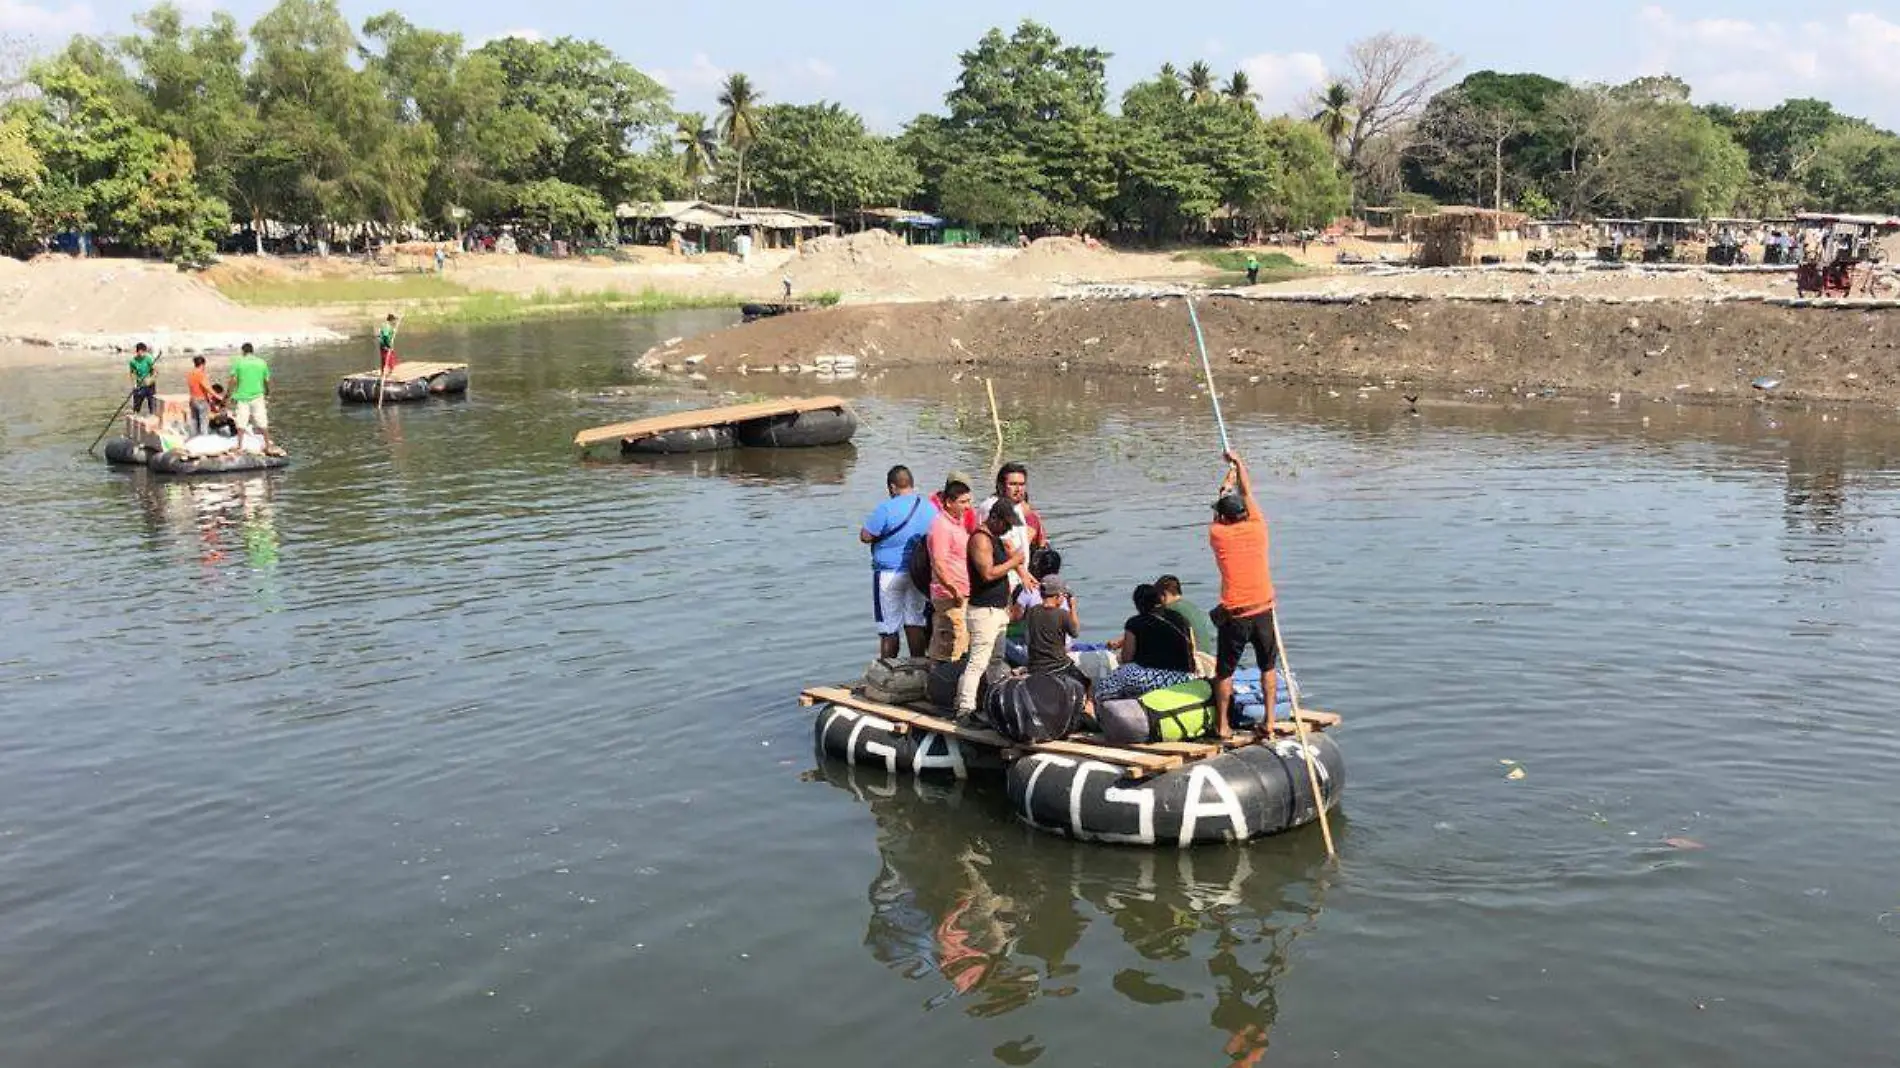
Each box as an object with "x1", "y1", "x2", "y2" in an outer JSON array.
[{"x1": 574, "y1": 397, "x2": 857, "y2": 454}]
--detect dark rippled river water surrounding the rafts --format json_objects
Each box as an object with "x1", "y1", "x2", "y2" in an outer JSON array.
[{"x1": 0, "y1": 314, "x2": 1900, "y2": 1068}]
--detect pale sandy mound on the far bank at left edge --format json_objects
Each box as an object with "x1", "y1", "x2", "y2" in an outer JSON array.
[{"x1": 0, "y1": 257, "x2": 342, "y2": 352}]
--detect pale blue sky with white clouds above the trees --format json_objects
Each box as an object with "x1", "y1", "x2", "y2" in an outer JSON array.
[{"x1": 11, "y1": 0, "x2": 1900, "y2": 133}]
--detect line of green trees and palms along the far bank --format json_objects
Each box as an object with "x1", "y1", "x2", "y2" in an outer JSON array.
[{"x1": 0, "y1": 9, "x2": 1900, "y2": 262}]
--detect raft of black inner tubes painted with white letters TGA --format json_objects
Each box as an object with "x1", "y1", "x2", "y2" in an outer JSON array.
[{"x1": 800, "y1": 667, "x2": 1345, "y2": 848}]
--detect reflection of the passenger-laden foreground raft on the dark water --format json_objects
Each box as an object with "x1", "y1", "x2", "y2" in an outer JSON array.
[{"x1": 817, "y1": 758, "x2": 1324, "y2": 1064}]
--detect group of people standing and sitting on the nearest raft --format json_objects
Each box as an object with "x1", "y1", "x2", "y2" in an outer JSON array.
[{"x1": 859, "y1": 452, "x2": 1279, "y2": 739}]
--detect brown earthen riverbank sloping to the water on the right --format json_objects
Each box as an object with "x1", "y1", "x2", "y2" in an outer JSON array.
[{"x1": 646, "y1": 295, "x2": 1900, "y2": 405}]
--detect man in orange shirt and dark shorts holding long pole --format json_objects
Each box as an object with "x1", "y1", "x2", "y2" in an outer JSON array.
[{"x1": 1207, "y1": 450, "x2": 1281, "y2": 737}]
